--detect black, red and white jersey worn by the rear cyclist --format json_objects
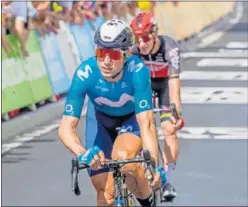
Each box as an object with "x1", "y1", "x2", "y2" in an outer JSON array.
[{"x1": 133, "y1": 36, "x2": 180, "y2": 78}]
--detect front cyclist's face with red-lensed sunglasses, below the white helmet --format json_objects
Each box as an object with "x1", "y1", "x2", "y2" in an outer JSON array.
[{"x1": 96, "y1": 48, "x2": 124, "y2": 78}]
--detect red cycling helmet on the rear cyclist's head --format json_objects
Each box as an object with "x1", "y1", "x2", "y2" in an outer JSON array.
[{"x1": 130, "y1": 12, "x2": 158, "y2": 36}]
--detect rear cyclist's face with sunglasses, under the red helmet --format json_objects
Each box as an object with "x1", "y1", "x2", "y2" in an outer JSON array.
[{"x1": 135, "y1": 34, "x2": 155, "y2": 55}]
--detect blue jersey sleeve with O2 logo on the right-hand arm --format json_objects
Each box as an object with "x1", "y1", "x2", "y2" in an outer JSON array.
[{"x1": 132, "y1": 59, "x2": 152, "y2": 114}]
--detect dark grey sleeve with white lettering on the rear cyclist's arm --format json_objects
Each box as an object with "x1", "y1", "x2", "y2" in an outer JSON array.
[{"x1": 165, "y1": 37, "x2": 180, "y2": 75}]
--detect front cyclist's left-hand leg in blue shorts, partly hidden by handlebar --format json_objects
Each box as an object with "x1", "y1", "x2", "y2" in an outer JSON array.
[{"x1": 85, "y1": 110, "x2": 114, "y2": 206}]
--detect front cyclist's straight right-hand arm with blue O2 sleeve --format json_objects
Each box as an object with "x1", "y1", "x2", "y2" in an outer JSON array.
[{"x1": 133, "y1": 60, "x2": 158, "y2": 166}]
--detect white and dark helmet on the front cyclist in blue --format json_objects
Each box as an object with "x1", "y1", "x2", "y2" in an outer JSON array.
[{"x1": 94, "y1": 19, "x2": 134, "y2": 50}]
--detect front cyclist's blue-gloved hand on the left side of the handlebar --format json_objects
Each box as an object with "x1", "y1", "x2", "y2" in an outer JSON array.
[{"x1": 78, "y1": 146, "x2": 106, "y2": 170}]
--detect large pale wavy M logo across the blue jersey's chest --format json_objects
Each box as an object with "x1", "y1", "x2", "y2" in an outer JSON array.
[{"x1": 95, "y1": 93, "x2": 134, "y2": 108}]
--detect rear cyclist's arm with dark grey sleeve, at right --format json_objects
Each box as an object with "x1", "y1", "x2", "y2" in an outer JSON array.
[{"x1": 165, "y1": 39, "x2": 181, "y2": 113}]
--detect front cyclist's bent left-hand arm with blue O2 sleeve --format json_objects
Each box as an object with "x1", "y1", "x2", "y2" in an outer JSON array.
[{"x1": 59, "y1": 65, "x2": 88, "y2": 156}]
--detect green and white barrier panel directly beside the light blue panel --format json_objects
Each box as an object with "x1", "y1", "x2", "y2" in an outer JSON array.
[{"x1": 22, "y1": 31, "x2": 52, "y2": 103}]
